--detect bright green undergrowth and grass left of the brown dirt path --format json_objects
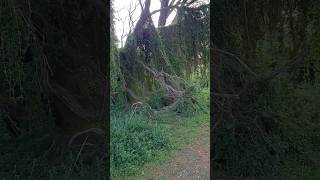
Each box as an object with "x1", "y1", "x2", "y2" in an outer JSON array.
[{"x1": 110, "y1": 90, "x2": 209, "y2": 179}]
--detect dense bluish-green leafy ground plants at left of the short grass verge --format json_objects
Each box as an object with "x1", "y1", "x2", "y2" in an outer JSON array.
[{"x1": 110, "y1": 110, "x2": 171, "y2": 177}]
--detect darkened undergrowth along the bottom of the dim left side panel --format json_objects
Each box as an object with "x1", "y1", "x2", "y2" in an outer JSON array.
[{"x1": 0, "y1": 129, "x2": 106, "y2": 180}]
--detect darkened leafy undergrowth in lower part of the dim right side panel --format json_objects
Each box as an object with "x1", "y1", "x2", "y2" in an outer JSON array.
[{"x1": 215, "y1": 78, "x2": 320, "y2": 179}]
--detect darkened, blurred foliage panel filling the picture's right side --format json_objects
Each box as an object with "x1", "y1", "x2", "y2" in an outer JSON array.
[{"x1": 211, "y1": 0, "x2": 320, "y2": 179}]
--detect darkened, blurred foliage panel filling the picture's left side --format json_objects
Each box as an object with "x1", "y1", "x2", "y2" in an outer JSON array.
[{"x1": 0, "y1": 0, "x2": 107, "y2": 179}]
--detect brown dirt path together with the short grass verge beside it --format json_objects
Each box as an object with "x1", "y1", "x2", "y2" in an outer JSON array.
[{"x1": 112, "y1": 114, "x2": 210, "y2": 180}]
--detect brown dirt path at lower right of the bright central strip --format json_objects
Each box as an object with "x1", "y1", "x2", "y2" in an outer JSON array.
[{"x1": 134, "y1": 127, "x2": 210, "y2": 180}]
